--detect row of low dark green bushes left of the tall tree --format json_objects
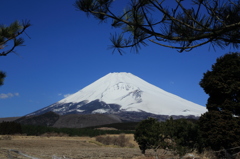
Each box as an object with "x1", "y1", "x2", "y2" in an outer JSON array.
[{"x1": 134, "y1": 118, "x2": 201, "y2": 155}]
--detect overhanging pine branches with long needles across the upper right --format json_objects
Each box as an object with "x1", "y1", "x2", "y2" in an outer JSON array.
[{"x1": 75, "y1": 0, "x2": 240, "y2": 54}]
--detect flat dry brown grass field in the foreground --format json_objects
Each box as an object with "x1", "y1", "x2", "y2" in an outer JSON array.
[{"x1": 0, "y1": 135, "x2": 164, "y2": 159}]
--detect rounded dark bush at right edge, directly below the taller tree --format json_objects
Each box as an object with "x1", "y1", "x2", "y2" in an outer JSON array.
[{"x1": 199, "y1": 111, "x2": 240, "y2": 151}]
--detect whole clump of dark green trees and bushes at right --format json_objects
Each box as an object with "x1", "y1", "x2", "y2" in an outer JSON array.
[{"x1": 135, "y1": 53, "x2": 240, "y2": 156}]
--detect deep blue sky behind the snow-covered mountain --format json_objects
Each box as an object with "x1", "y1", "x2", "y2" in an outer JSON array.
[{"x1": 0, "y1": 0, "x2": 235, "y2": 117}]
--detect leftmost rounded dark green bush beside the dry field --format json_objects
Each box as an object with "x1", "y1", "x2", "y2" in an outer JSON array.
[{"x1": 134, "y1": 118, "x2": 162, "y2": 154}]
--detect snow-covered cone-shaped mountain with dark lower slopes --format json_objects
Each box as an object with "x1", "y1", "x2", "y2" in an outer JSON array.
[{"x1": 28, "y1": 72, "x2": 207, "y2": 117}]
